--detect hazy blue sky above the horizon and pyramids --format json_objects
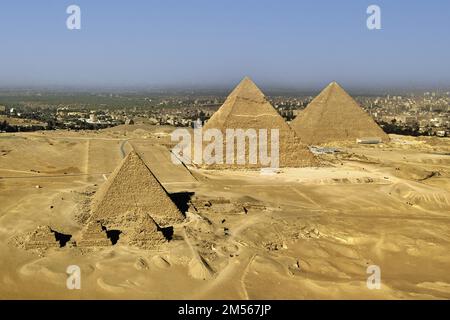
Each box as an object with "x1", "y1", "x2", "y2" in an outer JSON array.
[{"x1": 0, "y1": 0, "x2": 450, "y2": 89}]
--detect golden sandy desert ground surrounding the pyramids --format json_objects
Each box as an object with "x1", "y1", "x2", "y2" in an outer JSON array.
[{"x1": 0, "y1": 126, "x2": 450, "y2": 299}]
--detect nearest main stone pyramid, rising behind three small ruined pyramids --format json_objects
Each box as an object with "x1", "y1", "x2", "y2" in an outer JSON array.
[{"x1": 92, "y1": 151, "x2": 184, "y2": 228}]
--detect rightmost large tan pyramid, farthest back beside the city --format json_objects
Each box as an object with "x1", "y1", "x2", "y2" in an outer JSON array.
[{"x1": 291, "y1": 82, "x2": 389, "y2": 144}]
